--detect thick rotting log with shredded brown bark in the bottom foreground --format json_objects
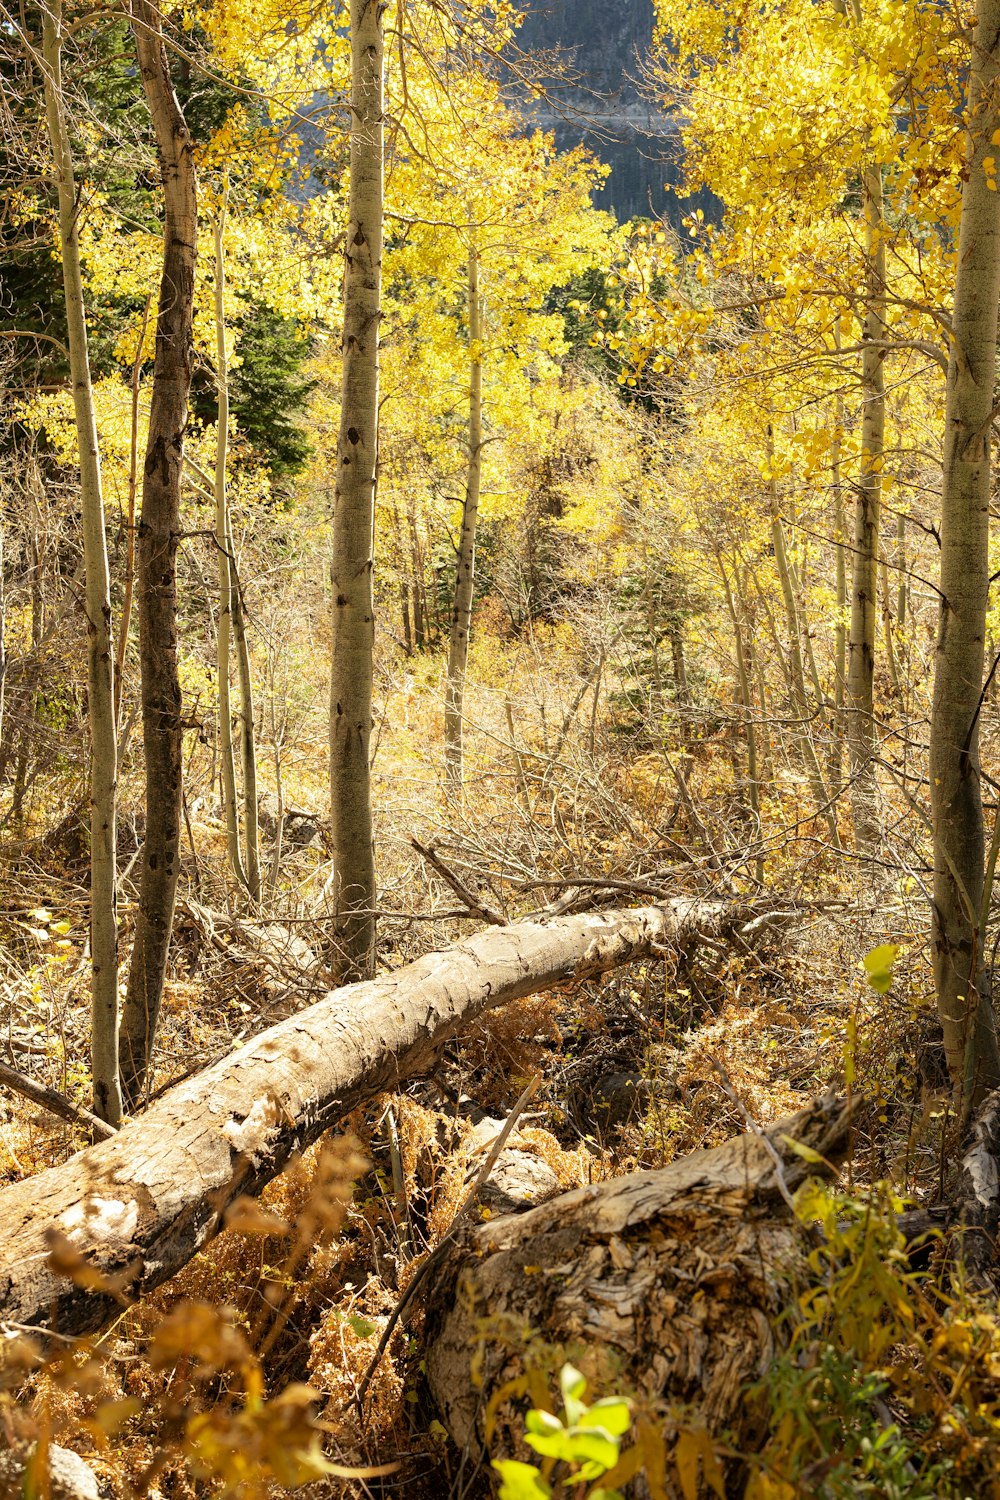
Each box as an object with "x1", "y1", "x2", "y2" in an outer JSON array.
[{"x1": 426, "y1": 1095, "x2": 849, "y2": 1458}]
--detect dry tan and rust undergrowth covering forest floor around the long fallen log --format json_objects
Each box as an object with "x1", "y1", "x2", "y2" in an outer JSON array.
[{"x1": 0, "y1": 618, "x2": 946, "y2": 1500}]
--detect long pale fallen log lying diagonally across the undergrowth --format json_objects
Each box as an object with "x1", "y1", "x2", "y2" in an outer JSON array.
[{"x1": 0, "y1": 900, "x2": 734, "y2": 1334}]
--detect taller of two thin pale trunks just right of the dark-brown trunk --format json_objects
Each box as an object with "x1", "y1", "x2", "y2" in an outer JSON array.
[{"x1": 213, "y1": 201, "x2": 250, "y2": 891}]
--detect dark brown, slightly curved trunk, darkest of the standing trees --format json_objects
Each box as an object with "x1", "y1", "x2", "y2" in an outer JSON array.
[{"x1": 120, "y1": 0, "x2": 198, "y2": 1107}]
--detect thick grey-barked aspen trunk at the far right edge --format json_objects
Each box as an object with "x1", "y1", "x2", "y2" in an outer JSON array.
[{"x1": 930, "y1": 0, "x2": 1000, "y2": 1116}]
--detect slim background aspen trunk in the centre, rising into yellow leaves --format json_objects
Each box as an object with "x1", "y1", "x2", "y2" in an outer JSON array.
[{"x1": 444, "y1": 251, "x2": 483, "y2": 791}]
